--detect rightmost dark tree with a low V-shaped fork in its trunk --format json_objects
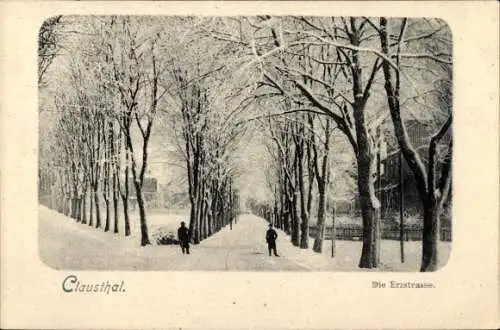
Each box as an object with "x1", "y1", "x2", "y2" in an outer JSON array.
[{"x1": 378, "y1": 17, "x2": 453, "y2": 271}]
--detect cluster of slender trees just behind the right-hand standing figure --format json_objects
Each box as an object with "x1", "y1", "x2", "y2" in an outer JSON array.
[{"x1": 250, "y1": 109, "x2": 333, "y2": 252}]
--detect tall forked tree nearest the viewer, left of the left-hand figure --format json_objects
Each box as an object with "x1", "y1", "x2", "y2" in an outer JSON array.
[{"x1": 108, "y1": 18, "x2": 164, "y2": 246}]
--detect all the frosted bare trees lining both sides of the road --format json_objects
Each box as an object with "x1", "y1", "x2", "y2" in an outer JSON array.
[{"x1": 39, "y1": 16, "x2": 452, "y2": 271}]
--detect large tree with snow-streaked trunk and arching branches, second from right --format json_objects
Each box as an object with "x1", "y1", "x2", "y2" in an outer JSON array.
[{"x1": 207, "y1": 16, "x2": 381, "y2": 268}]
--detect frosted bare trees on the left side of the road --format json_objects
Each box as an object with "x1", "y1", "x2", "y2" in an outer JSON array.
[{"x1": 39, "y1": 17, "x2": 242, "y2": 246}]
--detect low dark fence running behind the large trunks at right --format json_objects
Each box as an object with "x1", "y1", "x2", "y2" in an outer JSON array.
[{"x1": 309, "y1": 226, "x2": 451, "y2": 242}]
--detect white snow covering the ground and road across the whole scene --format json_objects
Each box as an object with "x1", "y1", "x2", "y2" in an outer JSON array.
[{"x1": 39, "y1": 206, "x2": 450, "y2": 271}]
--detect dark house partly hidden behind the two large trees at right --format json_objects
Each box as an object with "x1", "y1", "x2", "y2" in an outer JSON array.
[{"x1": 378, "y1": 120, "x2": 452, "y2": 218}]
